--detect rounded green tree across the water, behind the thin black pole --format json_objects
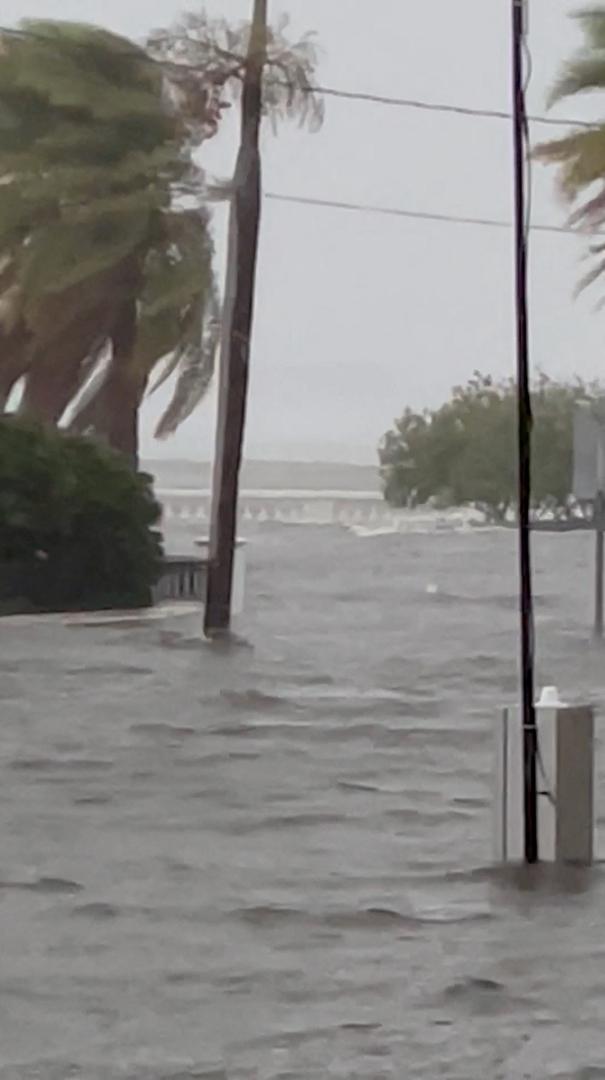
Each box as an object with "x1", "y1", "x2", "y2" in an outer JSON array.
[{"x1": 379, "y1": 373, "x2": 603, "y2": 523}]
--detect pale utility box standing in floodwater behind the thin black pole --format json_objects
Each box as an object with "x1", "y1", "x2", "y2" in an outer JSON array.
[{"x1": 494, "y1": 687, "x2": 594, "y2": 866}]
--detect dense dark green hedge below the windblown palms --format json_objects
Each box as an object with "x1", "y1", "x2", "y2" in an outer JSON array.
[{"x1": 0, "y1": 417, "x2": 162, "y2": 611}]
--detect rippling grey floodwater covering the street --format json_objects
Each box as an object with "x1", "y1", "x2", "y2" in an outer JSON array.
[{"x1": 0, "y1": 526, "x2": 605, "y2": 1080}]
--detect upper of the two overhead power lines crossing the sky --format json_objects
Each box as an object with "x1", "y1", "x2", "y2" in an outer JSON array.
[{"x1": 0, "y1": 26, "x2": 596, "y2": 129}]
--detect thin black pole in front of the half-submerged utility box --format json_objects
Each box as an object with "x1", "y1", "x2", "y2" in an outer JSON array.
[{"x1": 511, "y1": 0, "x2": 539, "y2": 863}]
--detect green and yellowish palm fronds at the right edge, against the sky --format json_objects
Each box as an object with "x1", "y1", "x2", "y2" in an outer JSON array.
[{"x1": 535, "y1": 6, "x2": 605, "y2": 300}]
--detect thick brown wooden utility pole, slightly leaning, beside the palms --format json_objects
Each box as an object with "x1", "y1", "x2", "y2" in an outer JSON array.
[{"x1": 204, "y1": 0, "x2": 268, "y2": 637}]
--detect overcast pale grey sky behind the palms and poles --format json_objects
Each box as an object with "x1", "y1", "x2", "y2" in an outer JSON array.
[{"x1": 2, "y1": 0, "x2": 605, "y2": 460}]
